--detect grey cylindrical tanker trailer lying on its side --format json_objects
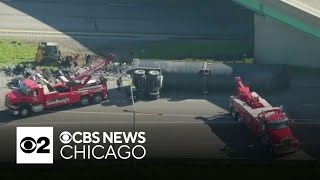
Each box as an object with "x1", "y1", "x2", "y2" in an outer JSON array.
[{"x1": 133, "y1": 59, "x2": 290, "y2": 93}]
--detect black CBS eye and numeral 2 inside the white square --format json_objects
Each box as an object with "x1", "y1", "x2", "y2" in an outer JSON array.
[{"x1": 20, "y1": 137, "x2": 50, "y2": 153}]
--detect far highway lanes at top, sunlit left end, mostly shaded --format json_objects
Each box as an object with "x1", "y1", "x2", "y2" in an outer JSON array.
[{"x1": 0, "y1": 0, "x2": 253, "y2": 38}]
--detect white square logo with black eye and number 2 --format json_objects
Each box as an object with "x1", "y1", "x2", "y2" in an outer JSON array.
[{"x1": 16, "y1": 127, "x2": 53, "y2": 164}]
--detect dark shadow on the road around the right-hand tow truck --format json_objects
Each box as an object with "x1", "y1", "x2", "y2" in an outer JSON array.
[{"x1": 195, "y1": 114, "x2": 320, "y2": 160}]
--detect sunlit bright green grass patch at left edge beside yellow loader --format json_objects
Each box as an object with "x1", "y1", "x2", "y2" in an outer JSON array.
[{"x1": 0, "y1": 40, "x2": 37, "y2": 67}]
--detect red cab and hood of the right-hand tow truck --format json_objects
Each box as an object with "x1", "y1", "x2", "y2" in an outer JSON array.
[{"x1": 258, "y1": 108, "x2": 299, "y2": 154}]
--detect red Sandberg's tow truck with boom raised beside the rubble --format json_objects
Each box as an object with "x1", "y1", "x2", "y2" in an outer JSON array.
[{"x1": 5, "y1": 54, "x2": 115, "y2": 117}]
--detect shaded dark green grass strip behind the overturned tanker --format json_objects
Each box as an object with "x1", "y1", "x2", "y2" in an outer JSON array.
[{"x1": 133, "y1": 40, "x2": 253, "y2": 59}]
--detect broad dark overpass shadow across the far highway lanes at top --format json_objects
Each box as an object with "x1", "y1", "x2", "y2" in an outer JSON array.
[{"x1": 3, "y1": 0, "x2": 253, "y2": 58}]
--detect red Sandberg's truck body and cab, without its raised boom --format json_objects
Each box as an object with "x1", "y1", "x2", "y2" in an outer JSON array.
[{"x1": 5, "y1": 75, "x2": 107, "y2": 117}]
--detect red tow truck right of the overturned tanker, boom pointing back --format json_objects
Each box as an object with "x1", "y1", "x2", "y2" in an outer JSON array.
[{"x1": 229, "y1": 77, "x2": 299, "y2": 154}]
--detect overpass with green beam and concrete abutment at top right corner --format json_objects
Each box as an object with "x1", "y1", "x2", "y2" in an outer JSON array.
[{"x1": 233, "y1": 0, "x2": 320, "y2": 67}]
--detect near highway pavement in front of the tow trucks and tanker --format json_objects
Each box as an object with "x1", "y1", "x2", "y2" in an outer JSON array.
[{"x1": 0, "y1": 86, "x2": 320, "y2": 162}]
